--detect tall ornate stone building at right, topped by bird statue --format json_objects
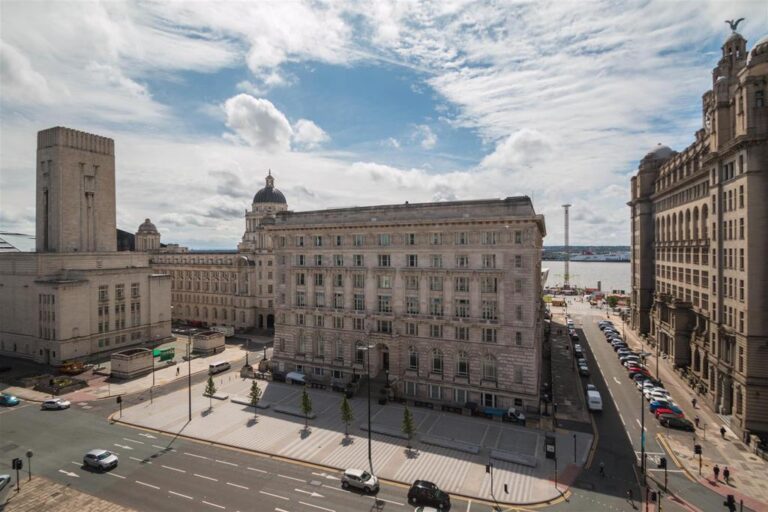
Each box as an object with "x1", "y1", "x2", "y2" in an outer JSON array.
[{"x1": 628, "y1": 26, "x2": 768, "y2": 438}]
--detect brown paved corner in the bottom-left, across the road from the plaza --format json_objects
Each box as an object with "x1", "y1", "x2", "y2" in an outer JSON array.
[{"x1": 0, "y1": 473, "x2": 134, "y2": 512}]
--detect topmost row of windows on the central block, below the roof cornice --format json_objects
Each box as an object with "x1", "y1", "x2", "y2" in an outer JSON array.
[{"x1": 278, "y1": 230, "x2": 523, "y2": 247}]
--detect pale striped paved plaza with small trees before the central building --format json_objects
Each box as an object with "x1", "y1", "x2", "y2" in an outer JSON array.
[{"x1": 115, "y1": 374, "x2": 592, "y2": 504}]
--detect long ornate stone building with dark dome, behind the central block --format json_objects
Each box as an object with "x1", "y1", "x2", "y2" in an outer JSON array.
[{"x1": 145, "y1": 171, "x2": 288, "y2": 332}]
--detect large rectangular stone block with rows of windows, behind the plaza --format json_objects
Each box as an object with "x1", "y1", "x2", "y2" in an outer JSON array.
[{"x1": 266, "y1": 197, "x2": 545, "y2": 409}]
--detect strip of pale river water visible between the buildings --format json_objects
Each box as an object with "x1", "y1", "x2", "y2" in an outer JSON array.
[{"x1": 541, "y1": 261, "x2": 632, "y2": 293}]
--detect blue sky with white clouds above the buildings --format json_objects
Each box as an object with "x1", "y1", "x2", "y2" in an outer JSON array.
[{"x1": 0, "y1": 0, "x2": 768, "y2": 249}]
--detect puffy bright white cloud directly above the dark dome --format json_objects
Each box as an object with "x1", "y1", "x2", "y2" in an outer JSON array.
[{"x1": 224, "y1": 94, "x2": 293, "y2": 151}]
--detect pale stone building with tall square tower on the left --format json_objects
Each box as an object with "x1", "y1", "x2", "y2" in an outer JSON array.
[{"x1": 0, "y1": 127, "x2": 171, "y2": 365}]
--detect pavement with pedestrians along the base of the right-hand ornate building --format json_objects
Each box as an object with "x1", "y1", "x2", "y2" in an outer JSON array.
[{"x1": 611, "y1": 315, "x2": 768, "y2": 510}]
